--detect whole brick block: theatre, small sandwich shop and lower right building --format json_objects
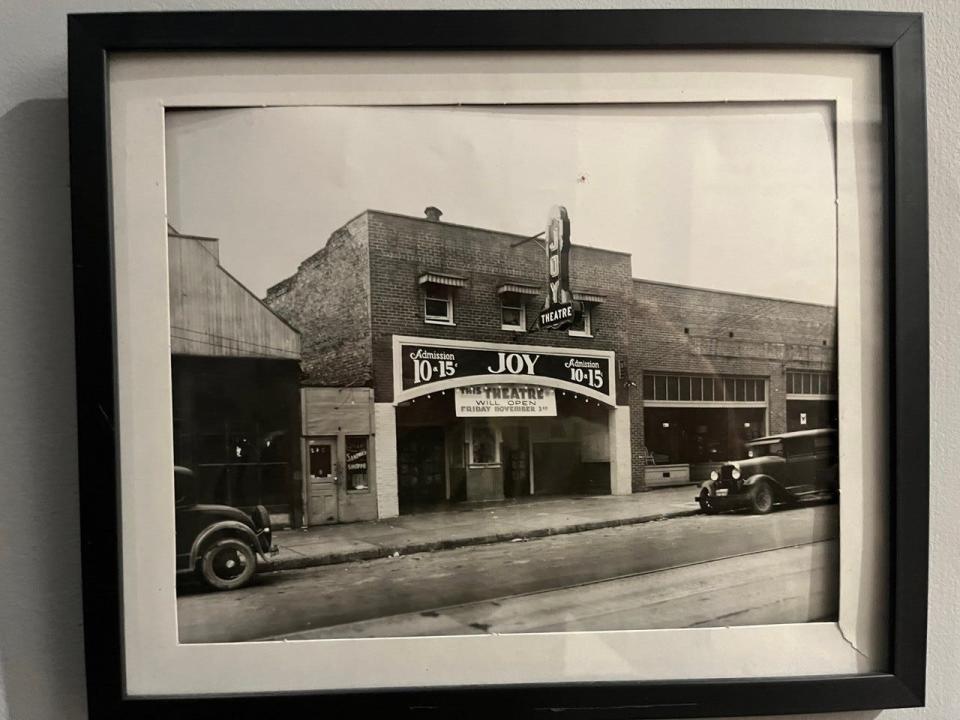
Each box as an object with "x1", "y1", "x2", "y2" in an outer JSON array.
[{"x1": 264, "y1": 208, "x2": 834, "y2": 524}]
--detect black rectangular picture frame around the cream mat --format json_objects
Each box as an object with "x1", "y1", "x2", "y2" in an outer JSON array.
[{"x1": 69, "y1": 10, "x2": 929, "y2": 719}]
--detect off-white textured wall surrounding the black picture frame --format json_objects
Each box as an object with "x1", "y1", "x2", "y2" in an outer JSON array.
[{"x1": 0, "y1": 0, "x2": 960, "y2": 720}]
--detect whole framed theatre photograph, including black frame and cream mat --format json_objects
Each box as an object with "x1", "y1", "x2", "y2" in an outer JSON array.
[{"x1": 69, "y1": 10, "x2": 929, "y2": 718}]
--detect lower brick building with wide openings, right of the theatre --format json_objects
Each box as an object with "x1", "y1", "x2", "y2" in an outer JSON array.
[{"x1": 629, "y1": 280, "x2": 837, "y2": 487}]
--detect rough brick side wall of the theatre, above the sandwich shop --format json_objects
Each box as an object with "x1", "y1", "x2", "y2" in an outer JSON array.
[{"x1": 264, "y1": 214, "x2": 372, "y2": 387}]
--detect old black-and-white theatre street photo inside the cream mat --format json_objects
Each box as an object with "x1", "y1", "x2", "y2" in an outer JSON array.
[{"x1": 166, "y1": 102, "x2": 840, "y2": 643}]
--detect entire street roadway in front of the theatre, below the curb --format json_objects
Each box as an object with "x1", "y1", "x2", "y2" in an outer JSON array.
[{"x1": 177, "y1": 505, "x2": 838, "y2": 643}]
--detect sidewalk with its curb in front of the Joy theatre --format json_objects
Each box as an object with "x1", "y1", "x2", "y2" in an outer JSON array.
[{"x1": 263, "y1": 483, "x2": 700, "y2": 571}]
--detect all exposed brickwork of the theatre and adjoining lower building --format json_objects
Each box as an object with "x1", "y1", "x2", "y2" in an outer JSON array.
[{"x1": 266, "y1": 210, "x2": 836, "y2": 496}]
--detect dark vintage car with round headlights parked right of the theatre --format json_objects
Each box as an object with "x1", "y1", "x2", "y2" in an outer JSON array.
[{"x1": 696, "y1": 428, "x2": 839, "y2": 513}]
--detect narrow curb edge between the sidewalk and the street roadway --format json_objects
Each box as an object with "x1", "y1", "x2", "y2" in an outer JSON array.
[{"x1": 260, "y1": 508, "x2": 700, "y2": 572}]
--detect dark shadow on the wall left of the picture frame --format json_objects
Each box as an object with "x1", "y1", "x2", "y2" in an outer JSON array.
[{"x1": 0, "y1": 99, "x2": 86, "y2": 720}]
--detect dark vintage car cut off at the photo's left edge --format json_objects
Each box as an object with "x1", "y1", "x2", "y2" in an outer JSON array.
[{"x1": 174, "y1": 466, "x2": 276, "y2": 590}]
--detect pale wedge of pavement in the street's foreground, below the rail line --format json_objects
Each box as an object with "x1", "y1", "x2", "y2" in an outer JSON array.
[{"x1": 272, "y1": 540, "x2": 840, "y2": 640}]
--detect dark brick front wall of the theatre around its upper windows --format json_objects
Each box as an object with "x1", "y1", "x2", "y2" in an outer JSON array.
[{"x1": 367, "y1": 211, "x2": 631, "y2": 405}]
